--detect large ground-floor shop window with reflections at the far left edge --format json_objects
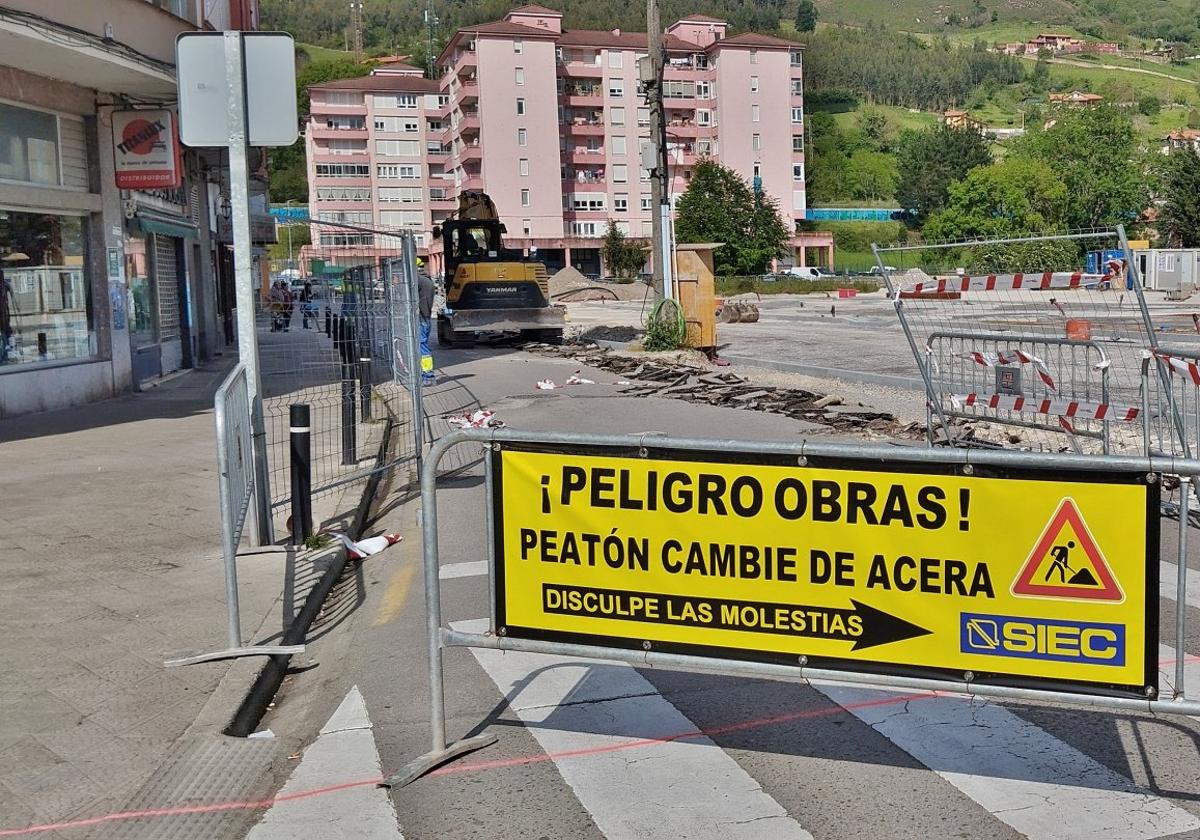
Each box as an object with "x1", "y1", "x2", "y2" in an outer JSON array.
[{"x1": 0, "y1": 208, "x2": 96, "y2": 370}]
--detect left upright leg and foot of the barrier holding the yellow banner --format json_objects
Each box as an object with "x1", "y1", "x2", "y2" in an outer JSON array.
[{"x1": 380, "y1": 436, "x2": 497, "y2": 787}]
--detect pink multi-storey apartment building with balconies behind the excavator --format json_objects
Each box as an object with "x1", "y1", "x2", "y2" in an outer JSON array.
[{"x1": 306, "y1": 6, "x2": 833, "y2": 274}]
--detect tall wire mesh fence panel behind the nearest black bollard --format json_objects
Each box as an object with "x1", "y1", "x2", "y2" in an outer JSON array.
[{"x1": 258, "y1": 234, "x2": 422, "y2": 518}]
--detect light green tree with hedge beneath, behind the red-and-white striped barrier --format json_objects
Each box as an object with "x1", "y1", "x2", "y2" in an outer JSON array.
[{"x1": 924, "y1": 157, "x2": 1076, "y2": 271}]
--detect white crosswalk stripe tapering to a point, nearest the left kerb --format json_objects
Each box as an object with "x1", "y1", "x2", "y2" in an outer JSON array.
[{"x1": 246, "y1": 685, "x2": 404, "y2": 840}]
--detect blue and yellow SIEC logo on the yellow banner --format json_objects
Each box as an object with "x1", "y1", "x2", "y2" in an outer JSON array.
[{"x1": 960, "y1": 612, "x2": 1126, "y2": 667}]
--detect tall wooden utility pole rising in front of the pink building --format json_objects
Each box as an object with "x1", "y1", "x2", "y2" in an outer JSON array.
[{"x1": 638, "y1": 0, "x2": 674, "y2": 298}]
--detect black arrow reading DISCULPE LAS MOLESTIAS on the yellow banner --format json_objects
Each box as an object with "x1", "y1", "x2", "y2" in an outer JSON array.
[{"x1": 541, "y1": 583, "x2": 932, "y2": 650}]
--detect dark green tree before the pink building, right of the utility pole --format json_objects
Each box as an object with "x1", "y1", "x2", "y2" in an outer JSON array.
[{"x1": 676, "y1": 161, "x2": 788, "y2": 275}]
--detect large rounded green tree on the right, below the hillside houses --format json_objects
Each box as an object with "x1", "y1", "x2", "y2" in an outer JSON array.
[{"x1": 1010, "y1": 106, "x2": 1150, "y2": 228}]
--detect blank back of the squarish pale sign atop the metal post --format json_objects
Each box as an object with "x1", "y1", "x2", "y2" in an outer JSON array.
[{"x1": 175, "y1": 32, "x2": 299, "y2": 146}]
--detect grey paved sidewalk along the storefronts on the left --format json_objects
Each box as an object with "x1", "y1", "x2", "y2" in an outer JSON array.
[{"x1": 0, "y1": 353, "x2": 288, "y2": 829}]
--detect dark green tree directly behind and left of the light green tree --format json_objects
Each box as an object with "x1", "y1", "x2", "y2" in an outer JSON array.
[{"x1": 895, "y1": 125, "x2": 991, "y2": 221}]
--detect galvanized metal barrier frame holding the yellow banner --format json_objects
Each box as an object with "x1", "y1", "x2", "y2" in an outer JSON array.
[{"x1": 385, "y1": 430, "x2": 1200, "y2": 786}]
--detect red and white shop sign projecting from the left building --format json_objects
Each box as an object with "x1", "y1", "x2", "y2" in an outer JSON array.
[{"x1": 113, "y1": 108, "x2": 182, "y2": 190}]
